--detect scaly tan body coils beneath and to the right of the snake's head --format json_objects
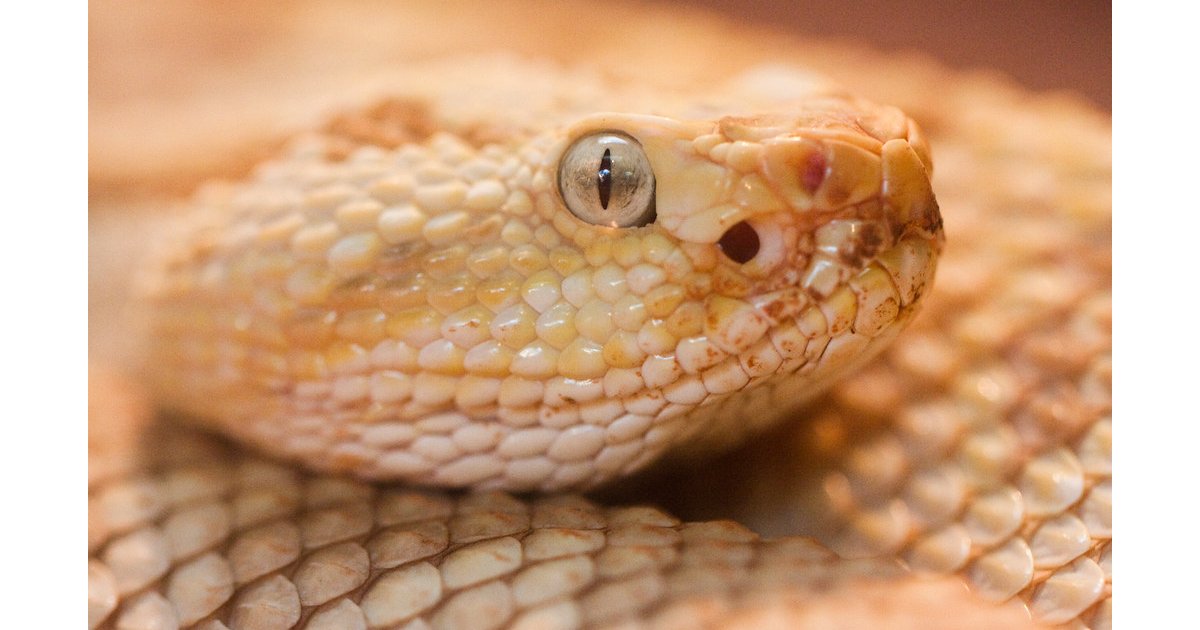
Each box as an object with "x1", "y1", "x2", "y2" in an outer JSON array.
[{"x1": 89, "y1": 51, "x2": 1111, "y2": 628}]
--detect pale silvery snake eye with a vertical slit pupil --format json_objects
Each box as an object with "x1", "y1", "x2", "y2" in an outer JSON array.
[{"x1": 558, "y1": 131, "x2": 655, "y2": 228}]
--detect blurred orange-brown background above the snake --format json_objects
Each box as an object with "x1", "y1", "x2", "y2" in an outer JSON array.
[{"x1": 88, "y1": 0, "x2": 1112, "y2": 200}]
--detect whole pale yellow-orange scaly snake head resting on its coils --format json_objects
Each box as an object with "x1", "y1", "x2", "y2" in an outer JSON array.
[{"x1": 146, "y1": 68, "x2": 942, "y2": 490}]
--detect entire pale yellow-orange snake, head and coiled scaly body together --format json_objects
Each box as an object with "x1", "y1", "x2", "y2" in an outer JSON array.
[{"x1": 88, "y1": 28, "x2": 1112, "y2": 629}]
